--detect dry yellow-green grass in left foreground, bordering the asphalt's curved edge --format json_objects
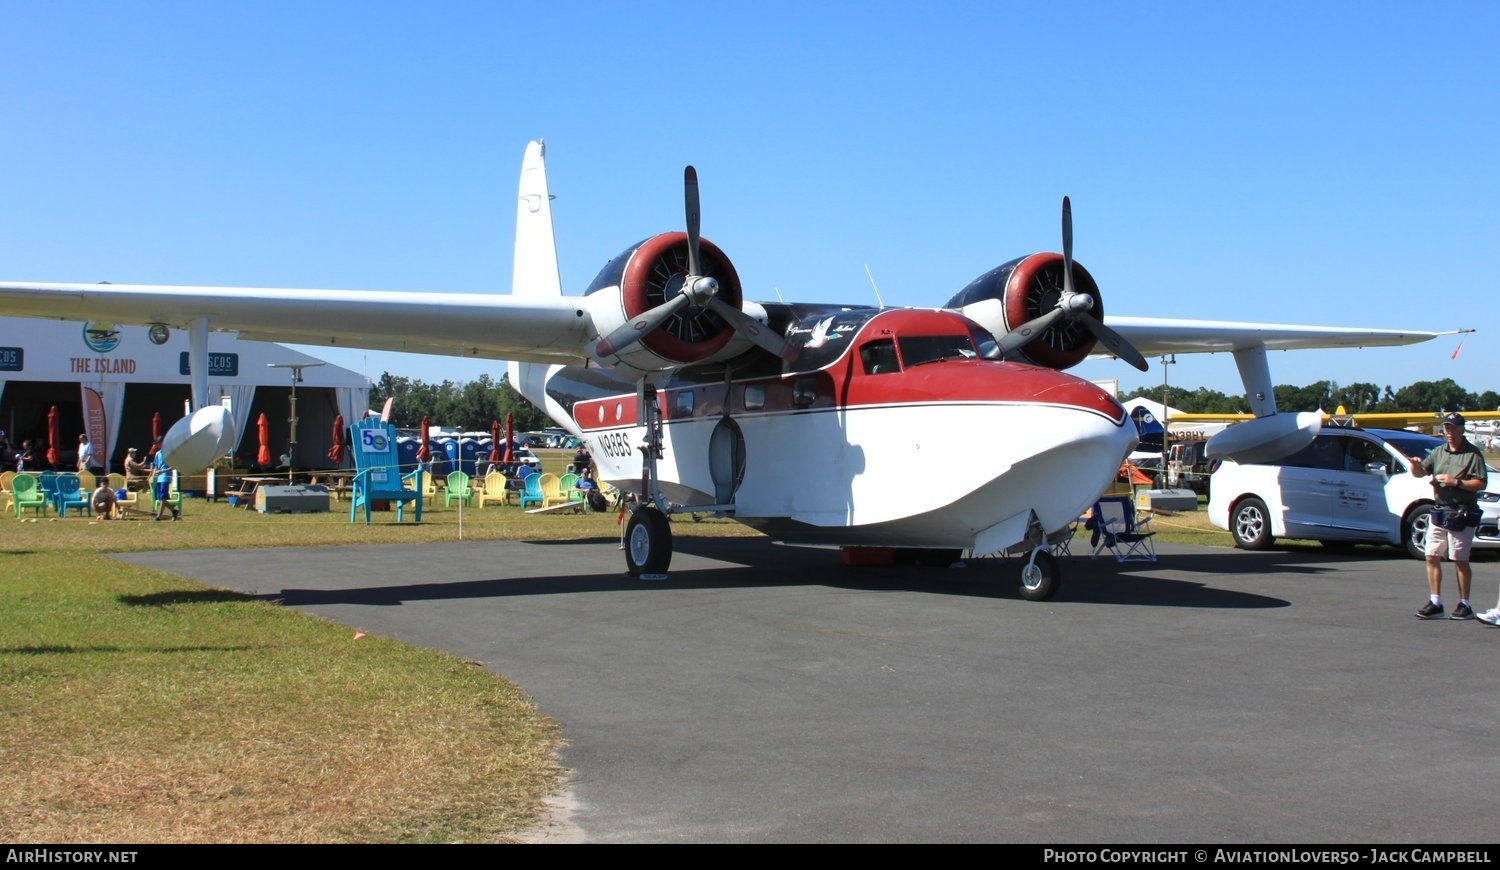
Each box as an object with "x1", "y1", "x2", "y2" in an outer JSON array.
[{"x1": 0, "y1": 528, "x2": 558, "y2": 843}]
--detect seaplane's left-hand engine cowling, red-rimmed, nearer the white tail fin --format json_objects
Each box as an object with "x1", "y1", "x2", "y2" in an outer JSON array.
[{"x1": 585, "y1": 233, "x2": 744, "y2": 372}]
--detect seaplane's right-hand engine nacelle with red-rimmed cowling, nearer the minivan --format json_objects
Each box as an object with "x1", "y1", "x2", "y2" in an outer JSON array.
[{"x1": 944, "y1": 254, "x2": 1104, "y2": 369}]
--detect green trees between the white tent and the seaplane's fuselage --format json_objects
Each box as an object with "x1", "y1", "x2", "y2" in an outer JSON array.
[{"x1": 371, "y1": 372, "x2": 552, "y2": 432}]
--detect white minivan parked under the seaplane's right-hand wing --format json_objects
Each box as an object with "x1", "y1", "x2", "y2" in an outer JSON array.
[{"x1": 1209, "y1": 428, "x2": 1500, "y2": 558}]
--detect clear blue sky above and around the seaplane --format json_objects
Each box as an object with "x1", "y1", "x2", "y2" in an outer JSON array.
[{"x1": 0, "y1": 2, "x2": 1500, "y2": 392}]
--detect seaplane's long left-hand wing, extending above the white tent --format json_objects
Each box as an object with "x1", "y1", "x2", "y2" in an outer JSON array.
[{"x1": 0, "y1": 282, "x2": 596, "y2": 365}]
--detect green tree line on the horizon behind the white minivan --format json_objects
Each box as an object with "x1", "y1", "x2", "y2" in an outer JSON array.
[{"x1": 1125, "y1": 378, "x2": 1500, "y2": 414}]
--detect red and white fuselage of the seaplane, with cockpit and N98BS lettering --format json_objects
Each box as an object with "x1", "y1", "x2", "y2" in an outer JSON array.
[{"x1": 546, "y1": 309, "x2": 1137, "y2": 552}]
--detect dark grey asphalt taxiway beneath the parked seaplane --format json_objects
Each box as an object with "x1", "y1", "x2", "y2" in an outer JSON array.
[{"x1": 119, "y1": 537, "x2": 1500, "y2": 843}]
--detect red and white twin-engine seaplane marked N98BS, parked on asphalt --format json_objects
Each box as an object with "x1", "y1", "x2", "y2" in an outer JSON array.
[{"x1": 0, "y1": 141, "x2": 1445, "y2": 600}]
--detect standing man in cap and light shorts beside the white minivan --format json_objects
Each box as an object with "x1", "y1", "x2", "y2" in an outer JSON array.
[{"x1": 1412, "y1": 414, "x2": 1490, "y2": 620}]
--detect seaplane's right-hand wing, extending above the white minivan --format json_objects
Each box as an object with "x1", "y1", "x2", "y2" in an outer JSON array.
[{"x1": 1092, "y1": 317, "x2": 1454, "y2": 357}]
